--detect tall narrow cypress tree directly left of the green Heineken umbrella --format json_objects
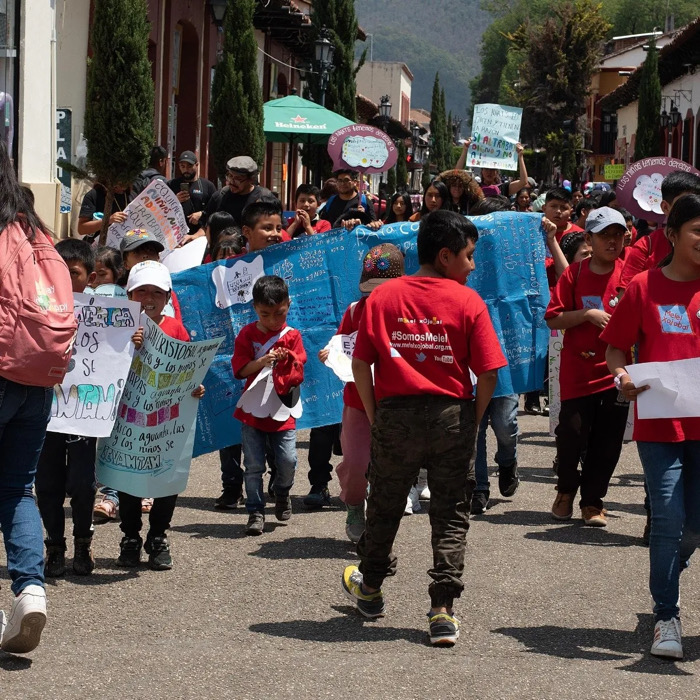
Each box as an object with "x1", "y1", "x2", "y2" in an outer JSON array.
[{"x1": 209, "y1": 0, "x2": 265, "y2": 176}]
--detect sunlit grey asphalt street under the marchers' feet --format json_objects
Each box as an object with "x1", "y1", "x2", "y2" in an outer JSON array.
[{"x1": 0, "y1": 415, "x2": 700, "y2": 700}]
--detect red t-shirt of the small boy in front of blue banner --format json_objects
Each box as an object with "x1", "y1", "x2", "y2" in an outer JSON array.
[{"x1": 231, "y1": 322, "x2": 306, "y2": 433}]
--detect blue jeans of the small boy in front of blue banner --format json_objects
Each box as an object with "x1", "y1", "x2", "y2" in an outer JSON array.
[{"x1": 241, "y1": 423, "x2": 297, "y2": 513}]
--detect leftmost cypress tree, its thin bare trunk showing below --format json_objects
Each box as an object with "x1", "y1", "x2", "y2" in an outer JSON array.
[{"x1": 85, "y1": 0, "x2": 154, "y2": 245}]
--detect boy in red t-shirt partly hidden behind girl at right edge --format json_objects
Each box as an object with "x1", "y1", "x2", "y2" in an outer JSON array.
[{"x1": 618, "y1": 170, "x2": 700, "y2": 296}]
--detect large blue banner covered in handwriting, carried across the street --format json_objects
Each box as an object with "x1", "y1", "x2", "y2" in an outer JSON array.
[{"x1": 173, "y1": 212, "x2": 549, "y2": 456}]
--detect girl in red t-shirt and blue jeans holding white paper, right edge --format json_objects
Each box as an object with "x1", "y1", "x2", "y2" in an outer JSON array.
[{"x1": 601, "y1": 193, "x2": 700, "y2": 659}]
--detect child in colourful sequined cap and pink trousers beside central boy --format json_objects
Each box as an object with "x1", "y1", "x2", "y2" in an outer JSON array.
[{"x1": 318, "y1": 243, "x2": 404, "y2": 543}]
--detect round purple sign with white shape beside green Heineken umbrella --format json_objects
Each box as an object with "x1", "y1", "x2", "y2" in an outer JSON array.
[{"x1": 328, "y1": 124, "x2": 398, "y2": 173}]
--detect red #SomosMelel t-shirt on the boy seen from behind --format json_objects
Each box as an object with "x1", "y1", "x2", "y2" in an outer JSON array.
[{"x1": 354, "y1": 277, "x2": 507, "y2": 400}]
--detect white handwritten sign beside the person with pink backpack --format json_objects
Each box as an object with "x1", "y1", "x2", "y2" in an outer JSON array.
[{"x1": 48, "y1": 294, "x2": 141, "y2": 437}]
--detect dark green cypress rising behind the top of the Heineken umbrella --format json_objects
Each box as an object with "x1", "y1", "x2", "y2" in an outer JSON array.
[{"x1": 309, "y1": 0, "x2": 364, "y2": 121}]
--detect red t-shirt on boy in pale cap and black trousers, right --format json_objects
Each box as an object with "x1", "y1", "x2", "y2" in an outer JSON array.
[{"x1": 544, "y1": 258, "x2": 632, "y2": 401}]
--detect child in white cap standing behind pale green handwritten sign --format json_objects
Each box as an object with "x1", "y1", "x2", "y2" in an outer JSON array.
[{"x1": 117, "y1": 260, "x2": 204, "y2": 571}]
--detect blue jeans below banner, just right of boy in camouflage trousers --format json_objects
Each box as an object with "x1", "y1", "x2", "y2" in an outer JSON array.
[{"x1": 474, "y1": 394, "x2": 519, "y2": 493}]
